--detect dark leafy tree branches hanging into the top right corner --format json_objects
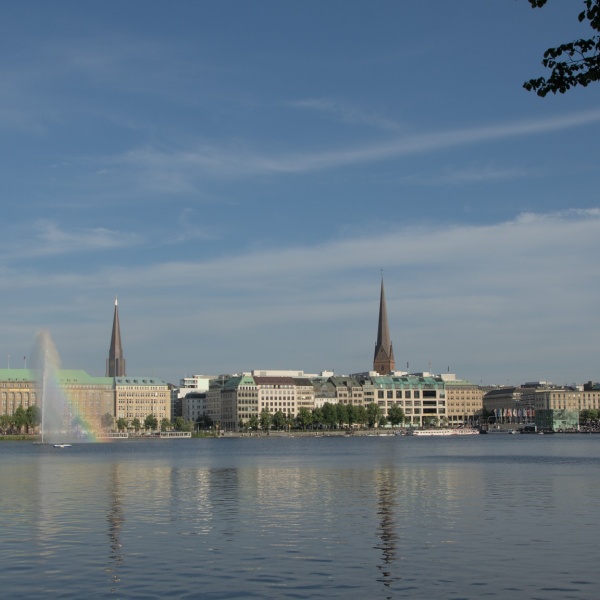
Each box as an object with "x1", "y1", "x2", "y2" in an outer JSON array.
[{"x1": 523, "y1": 0, "x2": 600, "y2": 97}]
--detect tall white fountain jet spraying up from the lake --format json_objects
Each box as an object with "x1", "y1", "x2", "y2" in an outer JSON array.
[{"x1": 32, "y1": 330, "x2": 69, "y2": 444}]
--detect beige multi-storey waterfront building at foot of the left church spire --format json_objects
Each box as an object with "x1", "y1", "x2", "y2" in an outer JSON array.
[{"x1": 114, "y1": 377, "x2": 171, "y2": 426}]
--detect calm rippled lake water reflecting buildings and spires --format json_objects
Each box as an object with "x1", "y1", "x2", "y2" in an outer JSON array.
[{"x1": 0, "y1": 435, "x2": 600, "y2": 600}]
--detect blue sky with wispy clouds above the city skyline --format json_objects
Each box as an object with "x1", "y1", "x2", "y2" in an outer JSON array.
[{"x1": 0, "y1": 0, "x2": 600, "y2": 384}]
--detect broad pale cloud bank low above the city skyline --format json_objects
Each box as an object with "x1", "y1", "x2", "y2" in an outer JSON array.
[{"x1": 0, "y1": 208, "x2": 600, "y2": 379}]
